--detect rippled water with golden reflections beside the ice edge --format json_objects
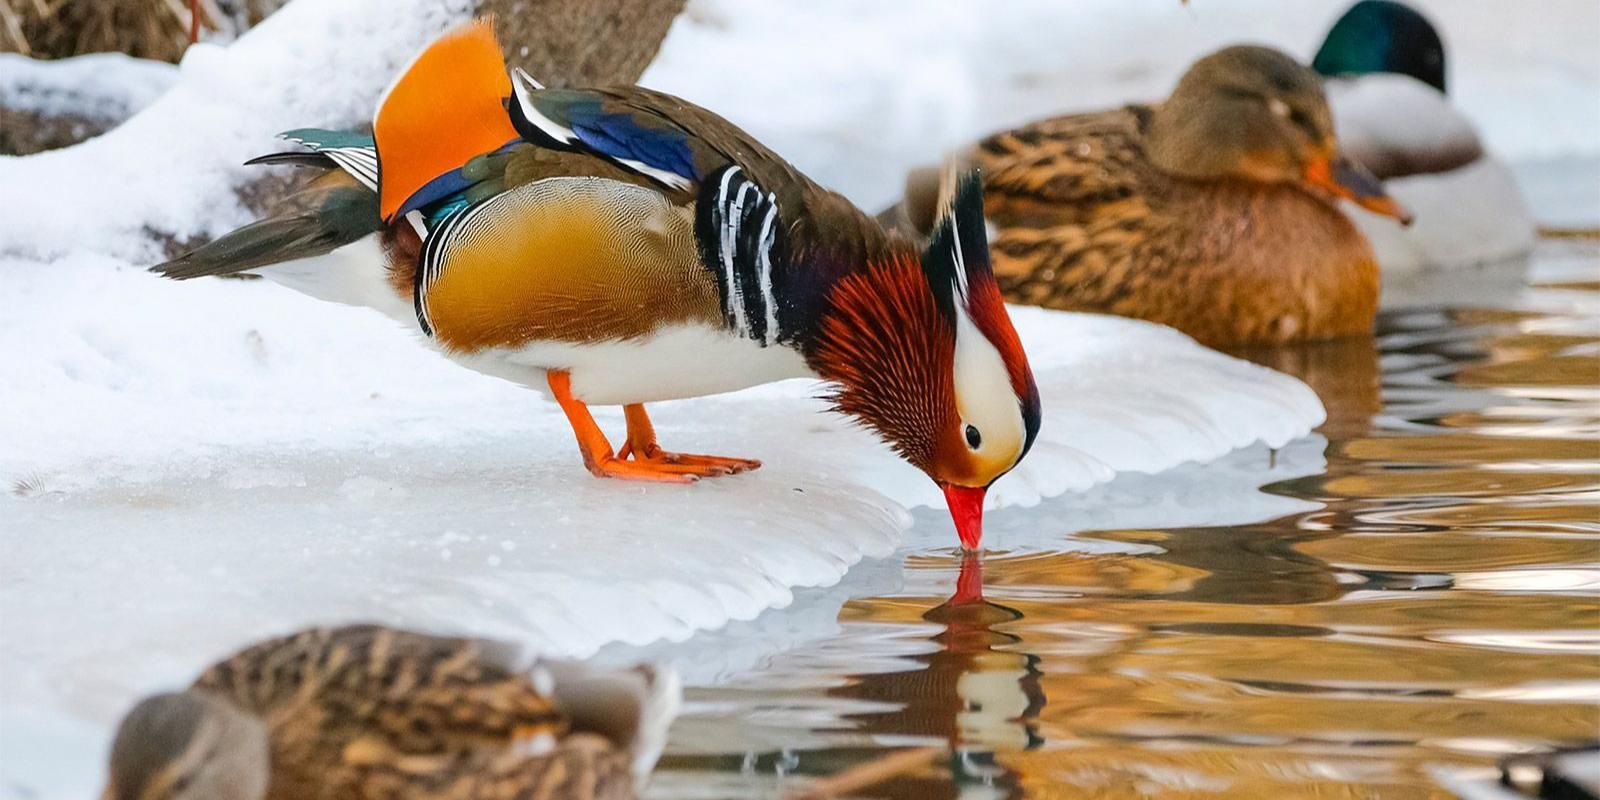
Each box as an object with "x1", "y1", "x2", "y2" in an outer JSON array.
[{"x1": 653, "y1": 242, "x2": 1600, "y2": 798}]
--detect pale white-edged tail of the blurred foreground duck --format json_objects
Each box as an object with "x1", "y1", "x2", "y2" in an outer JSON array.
[{"x1": 534, "y1": 661, "x2": 683, "y2": 786}]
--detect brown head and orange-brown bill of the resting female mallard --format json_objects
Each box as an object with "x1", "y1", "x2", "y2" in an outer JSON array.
[{"x1": 1147, "y1": 45, "x2": 1411, "y2": 224}]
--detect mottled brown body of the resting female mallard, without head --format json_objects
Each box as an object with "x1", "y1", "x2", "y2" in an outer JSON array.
[{"x1": 987, "y1": 179, "x2": 1378, "y2": 347}]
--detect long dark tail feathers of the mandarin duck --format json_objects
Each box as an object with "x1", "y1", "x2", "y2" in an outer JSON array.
[{"x1": 150, "y1": 178, "x2": 379, "y2": 280}]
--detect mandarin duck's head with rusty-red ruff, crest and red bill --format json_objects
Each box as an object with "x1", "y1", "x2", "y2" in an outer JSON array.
[{"x1": 816, "y1": 171, "x2": 1040, "y2": 550}]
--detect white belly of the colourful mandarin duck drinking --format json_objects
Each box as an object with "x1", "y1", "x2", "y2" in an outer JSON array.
[{"x1": 450, "y1": 325, "x2": 814, "y2": 405}]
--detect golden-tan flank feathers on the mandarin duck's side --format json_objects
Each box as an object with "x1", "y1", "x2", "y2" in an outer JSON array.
[{"x1": 393, "y1": 178, "x2": 720, "y2": 352}]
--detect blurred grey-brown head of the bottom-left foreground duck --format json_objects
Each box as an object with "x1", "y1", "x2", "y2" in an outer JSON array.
[{"x1": 102, "y1": 691, "x2": 269, "y2": 800}]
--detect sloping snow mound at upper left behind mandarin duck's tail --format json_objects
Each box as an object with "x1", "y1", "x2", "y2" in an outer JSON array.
[{"x1": 0, "y1": 0, "x2": 470, "y2": 258}]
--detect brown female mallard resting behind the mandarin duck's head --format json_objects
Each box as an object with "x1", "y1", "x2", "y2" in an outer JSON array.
[{"x1": 880, "y1": 46, "x2": 1406, "y2": 347}]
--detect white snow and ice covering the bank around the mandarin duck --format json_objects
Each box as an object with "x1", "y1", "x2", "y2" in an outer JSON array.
[{"x1": 0, "y1": 0, "x2": 1600, "y2": 797}]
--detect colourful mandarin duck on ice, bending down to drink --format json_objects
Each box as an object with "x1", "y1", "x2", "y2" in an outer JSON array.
[{"x1": 152, "y1": 21, "x2": 1040, "y2": 549}]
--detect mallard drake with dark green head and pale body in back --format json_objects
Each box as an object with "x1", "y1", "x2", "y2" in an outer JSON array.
[{"x1": 1312, "y1": 0, "x2": 1536, "y2": 278}]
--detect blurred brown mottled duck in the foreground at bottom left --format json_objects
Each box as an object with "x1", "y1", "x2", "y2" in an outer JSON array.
[{"x1": 104, "y1": 626, "x2": 678, "y2": 800}]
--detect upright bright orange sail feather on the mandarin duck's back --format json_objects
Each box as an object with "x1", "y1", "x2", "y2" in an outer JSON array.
[{"x1": 373, "y1": 19, "x2": 518, "y2": 221}]
